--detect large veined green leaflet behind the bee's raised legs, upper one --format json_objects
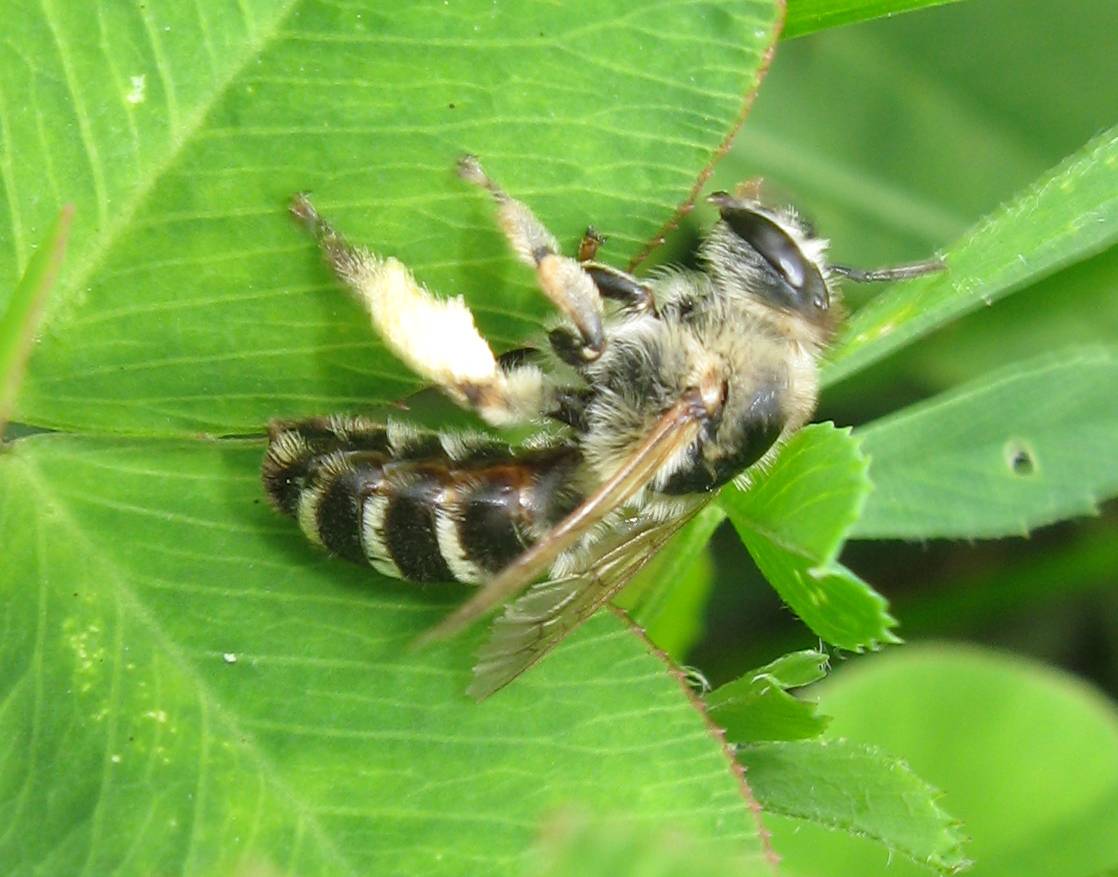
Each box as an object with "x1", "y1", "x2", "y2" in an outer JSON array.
[{"x1": 0, "y1": 0, "x2": 778, "y2": 435}]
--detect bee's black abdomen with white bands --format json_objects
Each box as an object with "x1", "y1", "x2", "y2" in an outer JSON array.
[{"x1": 263, "y1": 417, "x2": 581, "y2": 583}]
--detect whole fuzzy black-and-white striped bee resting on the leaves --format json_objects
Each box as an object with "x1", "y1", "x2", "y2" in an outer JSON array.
[{"x1": 263, "y1": 155, "x2": 941, "y2": 699}]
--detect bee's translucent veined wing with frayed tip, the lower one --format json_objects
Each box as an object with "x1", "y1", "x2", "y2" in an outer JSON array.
[{"x1": 470, "y1": 507, "x2": 707, "y2": 700}]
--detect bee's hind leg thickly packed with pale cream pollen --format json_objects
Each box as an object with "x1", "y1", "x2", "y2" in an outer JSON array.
[{"x1": 291, "y1": 195, "x2": 552, "y2": 426}]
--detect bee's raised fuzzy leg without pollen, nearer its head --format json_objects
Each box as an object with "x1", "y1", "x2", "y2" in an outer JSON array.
[{"x1": 458, "y1": 155, "x2": 606, "y2": 362}]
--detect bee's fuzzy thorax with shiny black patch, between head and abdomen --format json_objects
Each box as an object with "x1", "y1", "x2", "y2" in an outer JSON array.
[{"x1": 584, "y1": 279, "x2": 818, "y2": 497}]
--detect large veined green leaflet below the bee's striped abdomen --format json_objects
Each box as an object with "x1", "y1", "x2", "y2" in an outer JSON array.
[{"x1": 0, "y1": 435, "x2": 762, "y2": 877}]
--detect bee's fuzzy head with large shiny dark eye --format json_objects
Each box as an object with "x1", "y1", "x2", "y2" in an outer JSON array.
[{"x1": 708, "y1": 192, "x2": 831, "y2": 323}]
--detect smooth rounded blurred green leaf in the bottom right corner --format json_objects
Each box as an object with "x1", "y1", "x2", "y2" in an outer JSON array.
[{"x1": 764, "y1": 644, "x2": 1118, "y2": 877}]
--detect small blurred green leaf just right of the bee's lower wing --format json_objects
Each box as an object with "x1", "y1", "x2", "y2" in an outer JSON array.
[{"x1": 614, "y1": 506, "x2": 726, "y2": 662}]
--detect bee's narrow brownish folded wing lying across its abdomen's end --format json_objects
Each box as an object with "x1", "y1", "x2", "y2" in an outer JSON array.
[{"x1": 416, "y1": 390, "x2": 704, "y2": 647}]
